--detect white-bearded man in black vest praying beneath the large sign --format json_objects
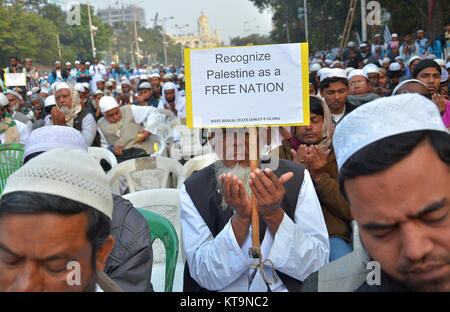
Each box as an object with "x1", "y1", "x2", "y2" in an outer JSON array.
[{"x1": 180, "y1": 129, "x2": 329, "y2": 292}]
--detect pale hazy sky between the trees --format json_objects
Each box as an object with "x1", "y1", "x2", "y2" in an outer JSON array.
[{"x1": 90, "y1": 0, "x2": 272, "y2": 45}]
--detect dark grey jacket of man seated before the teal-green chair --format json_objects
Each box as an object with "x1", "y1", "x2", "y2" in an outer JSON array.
[{"x1": 104, "y1": 194, "x2": 153, "y2": 292}]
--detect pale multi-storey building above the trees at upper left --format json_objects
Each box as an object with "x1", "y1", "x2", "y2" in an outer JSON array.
[{"x1": 98, "y1": 5, "x2": 146, "y2": 27}]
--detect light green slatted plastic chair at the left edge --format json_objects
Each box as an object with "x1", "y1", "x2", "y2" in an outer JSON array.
[{"x1": 0, "y1": 143, "x2": 25, "y2": 194}]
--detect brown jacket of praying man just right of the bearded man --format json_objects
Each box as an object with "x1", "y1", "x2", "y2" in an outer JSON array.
[{"x1": 278, "y1": 139, "x2": 353, "y2": 242}]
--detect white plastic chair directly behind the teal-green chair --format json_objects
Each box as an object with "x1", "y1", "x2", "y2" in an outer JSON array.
[{"x1": 123, "y1": 189, "x2": 186, "y2": 292}]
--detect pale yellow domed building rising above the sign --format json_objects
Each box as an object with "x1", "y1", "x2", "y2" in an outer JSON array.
[{"x1": 167, "y1": 11, "x2": 223, "y2": 48}]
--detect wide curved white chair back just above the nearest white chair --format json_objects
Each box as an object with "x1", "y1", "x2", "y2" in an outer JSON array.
[{"x1": 107, "y1": 157, "x2": 182, "y2": 195}]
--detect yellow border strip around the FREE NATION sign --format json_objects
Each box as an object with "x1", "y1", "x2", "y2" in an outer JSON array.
[{"x1": 184, "y1": 43, "x2": 310, "y2": 129}]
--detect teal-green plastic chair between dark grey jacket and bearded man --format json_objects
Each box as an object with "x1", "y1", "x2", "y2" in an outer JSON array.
[{"x1": 137, "y1": 208, "x2": 179, "y2": 292}]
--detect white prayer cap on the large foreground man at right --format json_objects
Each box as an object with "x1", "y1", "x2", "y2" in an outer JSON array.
[{"x1": 333, "y1": 93, "x2": 448, "y2": 170}]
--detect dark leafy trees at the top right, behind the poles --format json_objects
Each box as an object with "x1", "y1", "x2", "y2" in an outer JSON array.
[{"x1": 249, "y1": 0, "x2": 450, "y2": 51}]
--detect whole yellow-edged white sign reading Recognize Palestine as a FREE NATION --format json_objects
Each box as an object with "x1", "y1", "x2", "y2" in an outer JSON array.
[{"x1": 185, "y1": 43, "x2": 309, "y2": 128}]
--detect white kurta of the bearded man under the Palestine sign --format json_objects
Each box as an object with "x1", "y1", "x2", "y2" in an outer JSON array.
[{"x1": 180, "y1": 170, "x2": 330, "y2": 292}]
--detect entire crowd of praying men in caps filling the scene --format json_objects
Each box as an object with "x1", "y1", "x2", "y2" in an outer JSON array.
[{"x1": 0, "y1": 18, "x2": 450, "y2": 292}]
